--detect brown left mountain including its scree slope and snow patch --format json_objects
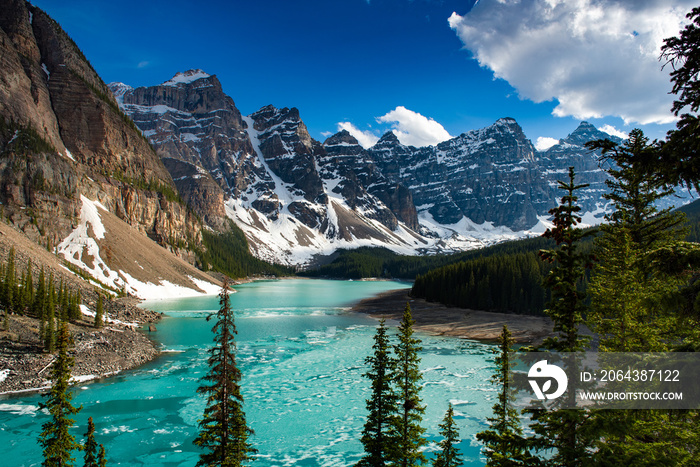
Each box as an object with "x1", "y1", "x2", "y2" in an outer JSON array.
[{"x1": 0, "y1": 0, "x2": 225, "y2": 296}]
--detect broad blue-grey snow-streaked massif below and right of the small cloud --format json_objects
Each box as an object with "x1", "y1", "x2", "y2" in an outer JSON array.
[{"x1": 370, "y1": 118, "x2": 553, "y2": 231}]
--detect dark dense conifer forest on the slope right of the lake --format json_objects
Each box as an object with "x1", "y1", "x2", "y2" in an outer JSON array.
[{"x1": 305, "y1": 200, "x2": 700, "y2": 314}]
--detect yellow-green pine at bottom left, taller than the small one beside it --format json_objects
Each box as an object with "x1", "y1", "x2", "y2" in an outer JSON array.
[{"x1": 39, "y1": 323, "x2": 82, "y2": 467}]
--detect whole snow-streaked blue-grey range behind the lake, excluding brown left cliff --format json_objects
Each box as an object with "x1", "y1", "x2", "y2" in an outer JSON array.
[{"x1": 109, "y1": 70, "x2": 620, "y2": 265}]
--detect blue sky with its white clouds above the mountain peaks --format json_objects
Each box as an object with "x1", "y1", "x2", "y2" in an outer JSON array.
[{"x1": 33, "y1": 0, "x2": 694, "y2": 149}]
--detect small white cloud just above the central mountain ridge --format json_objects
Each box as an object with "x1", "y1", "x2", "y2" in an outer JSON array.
[{"x1": 377, "y1": 106, "x2": 452, "y2": 147}]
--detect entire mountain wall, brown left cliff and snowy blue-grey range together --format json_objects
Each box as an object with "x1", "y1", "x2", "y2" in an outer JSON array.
[{"x1": 0, "y1": 0, "x2": 652, "y2": 282}]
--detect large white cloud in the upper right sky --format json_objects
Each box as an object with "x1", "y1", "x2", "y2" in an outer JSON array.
[{"x1": 448, "y1": 0, "x2": 697, "y2": 124}]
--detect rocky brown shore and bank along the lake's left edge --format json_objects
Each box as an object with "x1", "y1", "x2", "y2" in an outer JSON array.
[{"x1": 0, "y1": 222, "x2": 170, "y2": 397}]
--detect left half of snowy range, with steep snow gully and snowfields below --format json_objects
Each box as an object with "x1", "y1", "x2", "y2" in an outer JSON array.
[{"x1": 110, "y1": 70, "x2": 426, "y2": 264}]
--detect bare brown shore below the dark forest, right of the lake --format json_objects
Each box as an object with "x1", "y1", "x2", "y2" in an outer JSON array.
[{"x1": 352, "y1": 289, "x2": 552, "y2": 344}]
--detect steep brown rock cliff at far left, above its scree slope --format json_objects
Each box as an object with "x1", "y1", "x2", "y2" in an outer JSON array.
[{"x1": 0, "y1": 0, "x2": 201, "y2": 256}]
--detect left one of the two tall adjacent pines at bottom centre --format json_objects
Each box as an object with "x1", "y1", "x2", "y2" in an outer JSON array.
[{"x1": 357, "y1": 319, "x2": 398, "y2": 467}]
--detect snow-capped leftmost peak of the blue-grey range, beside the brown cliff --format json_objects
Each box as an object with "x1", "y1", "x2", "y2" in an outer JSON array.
[{"x1": 110, "y1": 70, "x2": 266, "y2": 230}]
